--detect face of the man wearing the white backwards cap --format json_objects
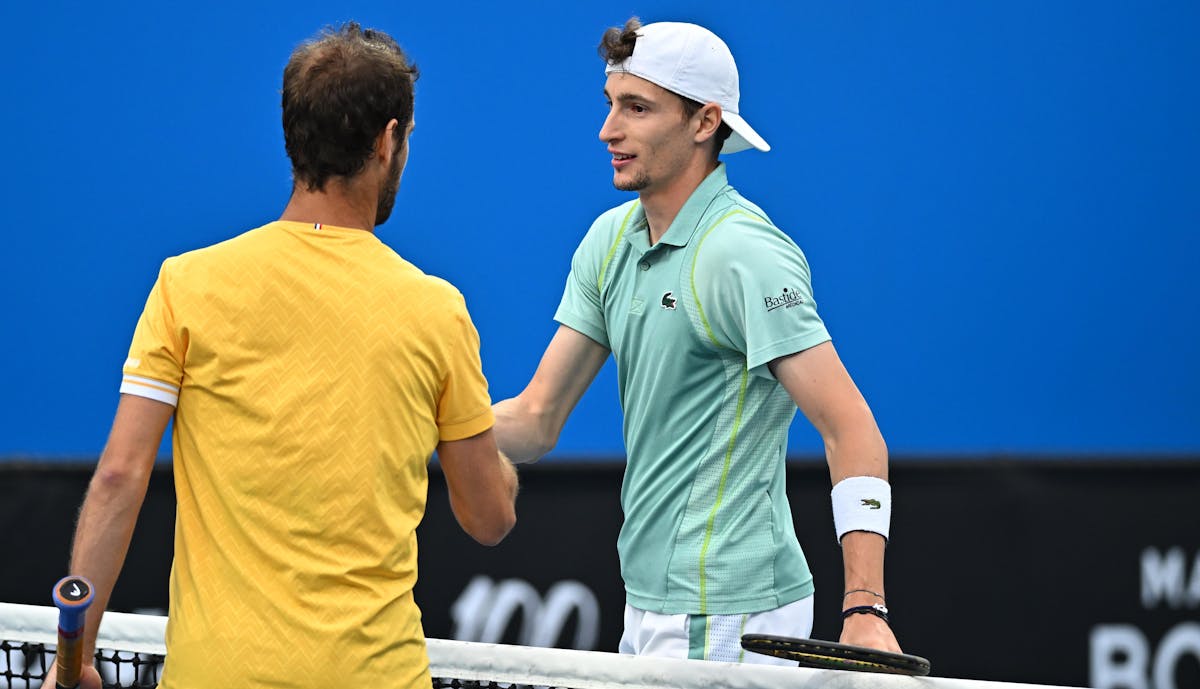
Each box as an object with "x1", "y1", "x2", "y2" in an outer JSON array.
[{"x1": 600, "y1": 72, "x2": 696, "y2": 193}]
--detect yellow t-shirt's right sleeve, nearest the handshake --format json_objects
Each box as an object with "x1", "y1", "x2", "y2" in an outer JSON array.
[{"x1": 437, "y1": 294, "x2": 496, "y2": 441}]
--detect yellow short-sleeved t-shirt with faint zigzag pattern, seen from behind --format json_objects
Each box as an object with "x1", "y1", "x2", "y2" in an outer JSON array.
[{"x1": 121, "y1": 222, "x2": 493, "y2": 689}]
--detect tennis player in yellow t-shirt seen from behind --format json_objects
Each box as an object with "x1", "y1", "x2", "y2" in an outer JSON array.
[{"x1": 48, "y1": 23, "x2": 516, "y2": 689}]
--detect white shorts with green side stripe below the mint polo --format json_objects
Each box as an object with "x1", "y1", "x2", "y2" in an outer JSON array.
[{"x1": 619, "y1": 595, "x2": 812, "y2": 665}]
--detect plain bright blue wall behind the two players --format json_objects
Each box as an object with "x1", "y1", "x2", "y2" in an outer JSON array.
[{"x1": 0, "y1": 0, "x2": 1200, "y2": 459}]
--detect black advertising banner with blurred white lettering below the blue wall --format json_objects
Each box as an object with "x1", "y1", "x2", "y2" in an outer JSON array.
[{"x1": 0, "y1": 460, "x2": 1200, "y2": 689}]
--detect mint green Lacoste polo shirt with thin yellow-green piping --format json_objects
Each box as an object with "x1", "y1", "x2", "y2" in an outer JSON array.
[{"x1": 554, "y1": 163, "x2": 829, "y2": 615}]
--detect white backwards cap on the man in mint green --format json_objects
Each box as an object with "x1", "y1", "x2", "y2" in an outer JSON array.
[{"x1": 605, "y1": 22, "x2": 770, "y2": 154}]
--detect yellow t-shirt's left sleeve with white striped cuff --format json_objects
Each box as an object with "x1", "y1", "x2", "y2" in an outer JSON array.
[{"x1": 120, "y1": 259, "x2": 187, "y2": 407}]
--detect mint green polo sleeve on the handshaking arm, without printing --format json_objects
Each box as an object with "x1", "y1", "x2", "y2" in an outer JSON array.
[{"x1": 554, "y1": 211, "x2": 620, "y2": 348}]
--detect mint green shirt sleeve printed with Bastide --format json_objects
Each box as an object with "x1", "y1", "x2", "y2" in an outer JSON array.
[{"x1": 696, "y1": 214, "x2": 830, "y2": 378}]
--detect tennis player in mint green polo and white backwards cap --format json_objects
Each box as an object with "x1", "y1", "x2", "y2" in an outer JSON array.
[{"x1": 494, "y1": 19, "x2": 900, "y2": 664}]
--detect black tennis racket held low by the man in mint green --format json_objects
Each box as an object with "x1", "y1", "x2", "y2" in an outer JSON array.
[{"x1": 742, "y1": 634, "x2": 929, "y2": 676}]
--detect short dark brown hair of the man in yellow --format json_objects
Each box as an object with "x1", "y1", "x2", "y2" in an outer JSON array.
[{"x1": 283, "y1": 22, "x2": 419, "y2": 191}]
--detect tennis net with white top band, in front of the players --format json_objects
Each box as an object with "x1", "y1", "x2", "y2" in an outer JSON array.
[{"x1": 0, "y1": 603, "x2": 1084, "y2": 689}]
